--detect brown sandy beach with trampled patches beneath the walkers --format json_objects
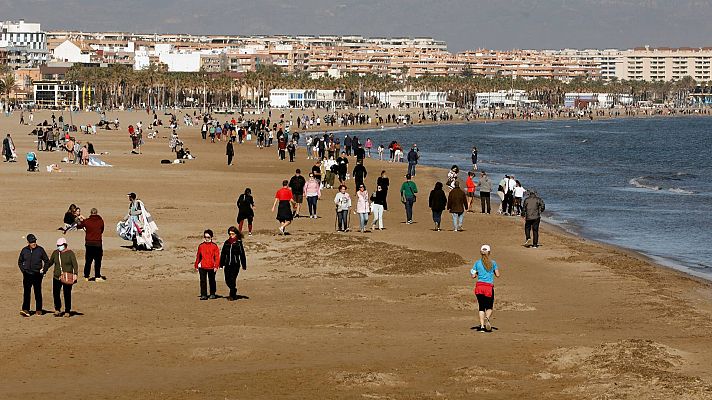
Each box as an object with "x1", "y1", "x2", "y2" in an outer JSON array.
[{"x1": 0, "y1": 111, "x2": 712, "y2": 399}]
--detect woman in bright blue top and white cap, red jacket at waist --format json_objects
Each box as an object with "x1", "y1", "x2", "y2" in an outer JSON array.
[{"x1": 470, "y1": 244, "x2": 499, "y2": 332}]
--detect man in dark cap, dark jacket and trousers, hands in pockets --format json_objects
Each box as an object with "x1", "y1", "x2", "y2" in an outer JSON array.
[{"x1": 17, "y1": 233, "x2": 49, "y2": 317}]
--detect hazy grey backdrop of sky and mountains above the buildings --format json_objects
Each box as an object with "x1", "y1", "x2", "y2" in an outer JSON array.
[{"x1": 5, "y1": 0, "x2": 712, "y2": 51}]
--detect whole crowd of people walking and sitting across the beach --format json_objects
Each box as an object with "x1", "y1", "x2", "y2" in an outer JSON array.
[{"x1": 9, "y1": 107, "x2": 545, "y2": 332}]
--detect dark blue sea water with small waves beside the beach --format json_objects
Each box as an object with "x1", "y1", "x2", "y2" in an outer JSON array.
[{"x1": 338, "y1": 117, "x2": 712, "y2": 279}]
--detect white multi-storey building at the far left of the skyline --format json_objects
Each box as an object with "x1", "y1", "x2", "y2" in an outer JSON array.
[{"x1": 0, "y1": 20, "x2": 49, "y2": 69}]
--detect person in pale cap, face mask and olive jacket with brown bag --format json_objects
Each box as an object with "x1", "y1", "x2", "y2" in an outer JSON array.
[{"x1": 43, "y1": 237, "x2": 79, "y2": 317}]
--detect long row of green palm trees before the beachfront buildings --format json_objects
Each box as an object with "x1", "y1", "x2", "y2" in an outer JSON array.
[{"x1": 65, "y1": 64, "x2": 708, "y2": 108}]
